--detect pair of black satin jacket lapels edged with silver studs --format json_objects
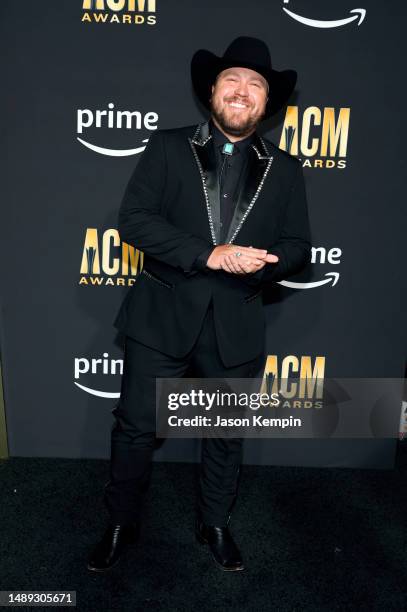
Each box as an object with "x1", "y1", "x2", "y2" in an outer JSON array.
[{"x1": 188, "y1": 122, "x2": 273, "y2": 245}]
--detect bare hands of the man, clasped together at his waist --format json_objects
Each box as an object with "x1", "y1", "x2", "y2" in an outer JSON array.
[{"x1": 206, "y1": 244, "x2": 278, "y2": 274}]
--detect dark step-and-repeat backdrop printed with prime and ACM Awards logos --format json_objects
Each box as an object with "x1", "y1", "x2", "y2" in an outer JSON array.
[{"x1": 0, "y1": 0, "x2": 407, "y2": 467}]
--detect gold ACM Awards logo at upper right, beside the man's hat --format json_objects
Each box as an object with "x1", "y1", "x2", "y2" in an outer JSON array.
[{"x1": 279, "y1": 106, "x2": 350, "y2": 169}]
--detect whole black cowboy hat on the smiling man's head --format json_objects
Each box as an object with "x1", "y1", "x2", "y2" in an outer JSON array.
[{"x1": 191, "y1": 36, "x2": 297, "y2": 119}]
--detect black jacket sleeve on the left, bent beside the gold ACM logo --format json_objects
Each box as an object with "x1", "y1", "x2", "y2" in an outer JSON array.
[{"x1": 118, "y1": 131, "x2": 214, "y2": 273}]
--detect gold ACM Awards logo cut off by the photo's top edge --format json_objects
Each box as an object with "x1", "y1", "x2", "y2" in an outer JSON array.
[{"x1": 81, "y1": 0, "x2": 157, "y2": 25}]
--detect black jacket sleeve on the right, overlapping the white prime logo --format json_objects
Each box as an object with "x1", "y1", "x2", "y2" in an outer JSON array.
[{"x1": 255, "y1": 162, "x2": 311, "y2": 284}]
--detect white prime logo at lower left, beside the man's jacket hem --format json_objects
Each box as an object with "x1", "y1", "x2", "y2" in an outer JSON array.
[{"x1": 74, "y1": 353, "x2": 123, "y2": 399}]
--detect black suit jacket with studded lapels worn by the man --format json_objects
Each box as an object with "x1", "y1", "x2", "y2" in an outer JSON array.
[{"x1": 114, "y1": 122, "x2": 311, "y2": 366}]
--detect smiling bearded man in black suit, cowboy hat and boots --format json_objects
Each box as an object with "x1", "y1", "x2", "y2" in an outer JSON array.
[{"x1": 88, "y1": 37, "x2": 310, "y2": 571}]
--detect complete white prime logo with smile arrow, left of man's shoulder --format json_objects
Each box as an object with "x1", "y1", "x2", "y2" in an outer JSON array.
[{"x1": 76, "y1": 102, "x2": 158, "y2": 157}]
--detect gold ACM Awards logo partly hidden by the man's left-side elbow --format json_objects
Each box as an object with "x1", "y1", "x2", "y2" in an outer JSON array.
[{"x1": 78, "y1": 227, "x2": 144, "y2": 287}]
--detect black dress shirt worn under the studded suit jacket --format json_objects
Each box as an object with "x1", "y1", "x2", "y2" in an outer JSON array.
[{"x1": 195, "y1": 119, "x2": 253, "y2": 270}]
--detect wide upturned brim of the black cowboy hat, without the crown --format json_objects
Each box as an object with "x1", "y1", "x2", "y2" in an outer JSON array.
[{"x1": 191, "y1": 49, "x2": 297, "y2": 119}]
